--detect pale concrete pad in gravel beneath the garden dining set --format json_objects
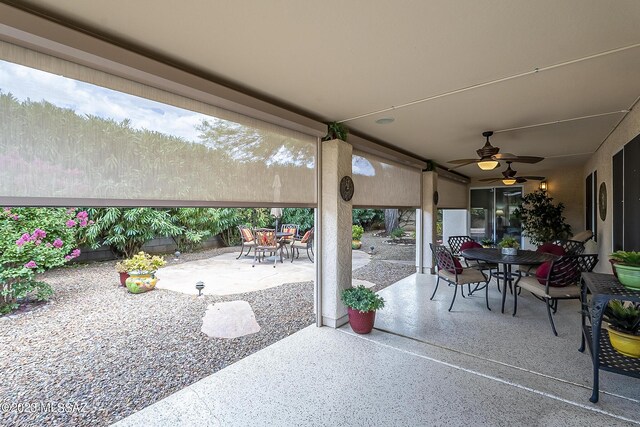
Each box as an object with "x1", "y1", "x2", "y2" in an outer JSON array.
[{"x1": 156, "y1": 251, "x2": 374, "y2": 295}]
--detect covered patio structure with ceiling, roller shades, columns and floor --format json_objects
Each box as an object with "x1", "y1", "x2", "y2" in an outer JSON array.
[{"x1": 0, "y1": 0, "x2": 640, "y2": 426}]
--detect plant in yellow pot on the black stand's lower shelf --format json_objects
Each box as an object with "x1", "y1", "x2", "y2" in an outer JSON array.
[{"x1": 604, "y1": 300, "x2": 640, "y2": 357}]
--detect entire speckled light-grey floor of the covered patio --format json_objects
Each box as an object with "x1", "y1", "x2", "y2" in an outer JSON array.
[{"x1": 116, "y1": 275, "x2": 640, "y2": 426}]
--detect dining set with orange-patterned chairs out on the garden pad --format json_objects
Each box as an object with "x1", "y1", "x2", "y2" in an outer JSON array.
[{"x1": 236, "y1": 224, "x2": 313, "y2": 268}]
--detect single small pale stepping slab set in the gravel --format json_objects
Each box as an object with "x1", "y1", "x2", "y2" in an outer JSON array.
[{"x1": 200, "y1": 301, "x2": 260, "y2": 338}]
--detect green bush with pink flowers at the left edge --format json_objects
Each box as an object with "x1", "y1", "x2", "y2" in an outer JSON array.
[{"x1": 0, "y1": 208, "x2": 88, "y2": 314}]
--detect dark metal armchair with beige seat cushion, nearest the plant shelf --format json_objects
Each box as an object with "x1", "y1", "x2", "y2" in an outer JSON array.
[{"x1": 513, "y1": 254, "x2": 598, "y2": 336}]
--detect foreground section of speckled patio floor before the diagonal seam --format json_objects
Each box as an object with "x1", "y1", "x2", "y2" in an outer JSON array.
[{"x1": 117, "y1": 326, "x2": 634, "y2": 427}]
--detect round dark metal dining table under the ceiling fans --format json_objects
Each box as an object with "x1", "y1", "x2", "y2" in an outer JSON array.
[{"x1": 460, "y1": 248, "x2": 558, "y2": 313}]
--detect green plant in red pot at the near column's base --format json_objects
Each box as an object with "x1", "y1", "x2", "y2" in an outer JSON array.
[{"x1": 340, "y1": 285, "x2": 384, "y2": 334}]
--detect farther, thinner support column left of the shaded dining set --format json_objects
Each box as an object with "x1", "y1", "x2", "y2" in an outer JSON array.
[{"x1": 418, "y1": 172, "x2": 438, "y2": 274}]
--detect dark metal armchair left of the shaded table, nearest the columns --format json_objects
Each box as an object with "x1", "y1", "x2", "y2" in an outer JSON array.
[{"x1": 429, "y1": 244, "x2": 491, "y2": 311}]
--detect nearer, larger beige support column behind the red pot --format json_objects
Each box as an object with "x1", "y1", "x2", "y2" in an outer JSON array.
[{"x1": 321, "y1": 139, "x2": 358, "y2": 328}]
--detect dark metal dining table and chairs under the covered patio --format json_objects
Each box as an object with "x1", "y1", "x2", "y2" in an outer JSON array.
[{"x1": 431, "y1": 232, "x2": 598, "y2": 336}]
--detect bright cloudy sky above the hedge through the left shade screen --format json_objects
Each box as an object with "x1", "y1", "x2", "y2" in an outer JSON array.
[{"x1": 0, "y1": 60, "x2": 210, "y2": 142}]
